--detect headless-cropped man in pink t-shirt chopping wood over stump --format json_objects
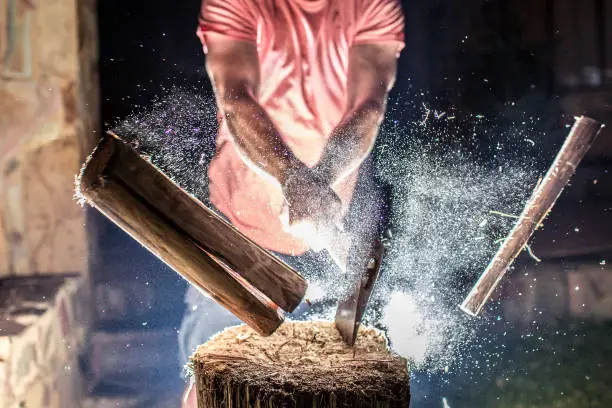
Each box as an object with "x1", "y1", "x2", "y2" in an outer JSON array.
[{"x1": 181, "y1": 0, "x2": 404, "y2": 406}]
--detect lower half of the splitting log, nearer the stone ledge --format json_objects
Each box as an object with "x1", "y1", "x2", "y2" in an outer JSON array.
[{"x1": 80, "y1": 137, "x2": 283, "y2": 335}]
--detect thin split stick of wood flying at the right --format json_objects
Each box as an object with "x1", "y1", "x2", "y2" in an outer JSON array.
[{"x1": 460, "y1": 116, "x2": 603, "y2": 316}]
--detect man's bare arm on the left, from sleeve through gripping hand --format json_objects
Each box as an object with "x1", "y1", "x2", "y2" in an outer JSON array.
[{"x1": 206, "y1": 33, "x2": 341, "y2": 225}]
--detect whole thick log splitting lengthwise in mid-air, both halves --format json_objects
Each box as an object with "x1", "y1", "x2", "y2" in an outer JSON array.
[{"x1": 77, "y1": 135, "x2": 306, "y2": 335}]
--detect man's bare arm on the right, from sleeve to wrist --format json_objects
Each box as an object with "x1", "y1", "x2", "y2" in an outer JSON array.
[{"x1": 313, "y1": 43, "x2": 397, "y2": 185}]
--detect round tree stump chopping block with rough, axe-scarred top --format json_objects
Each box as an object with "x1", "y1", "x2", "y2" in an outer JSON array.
[{"x1": 191, "y1": 321, "x2": 410, "y2": 408}]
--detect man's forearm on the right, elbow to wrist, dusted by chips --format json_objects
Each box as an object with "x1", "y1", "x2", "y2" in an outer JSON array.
[{"x1": 313, "y1": 101, "x2": 385, "y2": 186}]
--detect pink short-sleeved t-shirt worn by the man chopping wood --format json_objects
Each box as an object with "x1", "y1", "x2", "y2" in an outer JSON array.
[{"x1": 198, "y1": 0, "x2": 404, "y2": 255}]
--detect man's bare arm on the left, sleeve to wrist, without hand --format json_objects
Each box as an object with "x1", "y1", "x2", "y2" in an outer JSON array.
[{"x1": 206, "y1": 33, "x2": 301, "y2": 186}]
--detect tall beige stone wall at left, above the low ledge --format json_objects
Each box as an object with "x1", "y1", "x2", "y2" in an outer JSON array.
[{"x1": 0, "y1": 0, "x2": 99, "y2": 276}]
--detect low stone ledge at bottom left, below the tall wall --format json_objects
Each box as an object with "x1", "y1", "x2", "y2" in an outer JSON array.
[{"x1": 0, "y1": 275, "x2": 91, "y2": 408}]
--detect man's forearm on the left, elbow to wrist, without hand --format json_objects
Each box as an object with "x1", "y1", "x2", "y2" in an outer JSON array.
[{"x1": 221, "y1": 94, "x2": 300, "y2": 185}]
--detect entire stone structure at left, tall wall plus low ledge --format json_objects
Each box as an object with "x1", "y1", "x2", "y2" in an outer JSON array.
[{"x1": 0, "y1": 0, "x2": 100, "y2": 408}]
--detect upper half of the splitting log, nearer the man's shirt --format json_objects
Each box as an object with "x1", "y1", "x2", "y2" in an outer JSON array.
[{"x1": 107, "y1": 132, "x2": 308, "y2": 311}]
